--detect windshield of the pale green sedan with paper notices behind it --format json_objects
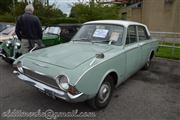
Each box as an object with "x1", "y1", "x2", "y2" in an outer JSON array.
[{"x1": 72, "y1": 24, "x2": 123, "y2": 45}]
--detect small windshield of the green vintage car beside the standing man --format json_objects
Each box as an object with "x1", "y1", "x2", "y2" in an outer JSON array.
[{"x1": 44, "y1": 27, "x2": 61, "y2": 35}]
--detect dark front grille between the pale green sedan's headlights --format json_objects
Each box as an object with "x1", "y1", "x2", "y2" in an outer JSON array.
[{"x1": 23, "y1": 68, "x2": 59, "y2": 89}]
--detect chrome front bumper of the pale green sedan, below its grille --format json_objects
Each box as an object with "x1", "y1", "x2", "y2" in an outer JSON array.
[{"x1": 13, "y1": 71, "x2": 88, "y2": 102}]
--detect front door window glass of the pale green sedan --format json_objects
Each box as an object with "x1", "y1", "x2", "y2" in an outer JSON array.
[{"x1": 126, "y1": 26, "x2": 137, "y2": 44}]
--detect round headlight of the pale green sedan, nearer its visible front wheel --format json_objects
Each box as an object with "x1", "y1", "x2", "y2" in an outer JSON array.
[{"x1": 56, "y1": 75, "x2": 69, "y2": 91}]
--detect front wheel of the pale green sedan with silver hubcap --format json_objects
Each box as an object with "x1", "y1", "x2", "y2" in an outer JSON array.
[{"x1": 88, "y1": 76, "x2": 114, "y2": 110}]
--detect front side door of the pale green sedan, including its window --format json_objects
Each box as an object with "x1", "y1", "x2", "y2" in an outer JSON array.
[{"x1": 124, "y1": 25, "x2": 141, "y2": 78}]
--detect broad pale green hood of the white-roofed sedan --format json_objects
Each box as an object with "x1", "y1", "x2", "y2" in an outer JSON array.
[{"x1": 27, "y1": 42, "x2": 112, "y2": 69}]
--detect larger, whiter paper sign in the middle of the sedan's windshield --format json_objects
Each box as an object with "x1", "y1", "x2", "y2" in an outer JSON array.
[{"x1": 93, "y1": 29, "x2": 109, "y2": 38}]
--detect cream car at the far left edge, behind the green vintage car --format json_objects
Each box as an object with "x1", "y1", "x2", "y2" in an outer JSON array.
[{"x1": 0, "y1": 25, "x2": 17, "y2": 44}]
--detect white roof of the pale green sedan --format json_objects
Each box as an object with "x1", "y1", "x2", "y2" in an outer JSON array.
[{"x1": 84, "y1": 20, "x2": 146, "y2": 27}]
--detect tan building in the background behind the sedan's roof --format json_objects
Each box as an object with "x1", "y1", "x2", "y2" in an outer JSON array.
[{"x1": 120, "y1": 0, "x2": 180, "y2": 33}]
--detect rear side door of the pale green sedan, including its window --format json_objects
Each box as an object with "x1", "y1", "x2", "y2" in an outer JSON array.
[{"x1": 137, "y1": 26, "x2": 151, "y2": 66}]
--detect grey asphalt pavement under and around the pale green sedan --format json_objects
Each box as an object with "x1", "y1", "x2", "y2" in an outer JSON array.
[{"x1": 0, "y1": 58, "x2": 180, "y2": 120}]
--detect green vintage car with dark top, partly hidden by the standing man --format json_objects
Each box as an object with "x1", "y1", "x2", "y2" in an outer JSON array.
[{"x1": 0, "y1": 24, "x2": 81, "y2": 64}]
